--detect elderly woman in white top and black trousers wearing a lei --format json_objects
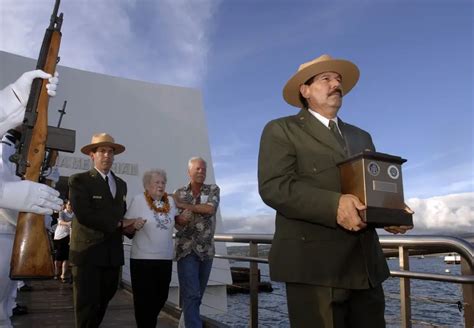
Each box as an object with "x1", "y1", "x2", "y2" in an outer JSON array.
[{"x1": 125, "y1": 169, "x2": 177, "y2": 328}]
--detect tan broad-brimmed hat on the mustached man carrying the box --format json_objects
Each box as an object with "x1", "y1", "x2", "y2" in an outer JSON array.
[{"x1": 283, "y1": 59, "x2": 360, "y2": 108}]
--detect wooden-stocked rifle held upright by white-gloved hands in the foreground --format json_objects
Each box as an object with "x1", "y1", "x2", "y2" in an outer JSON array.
[{"x1": 10, "y1": 0, "x2": 63, "y2": 280}]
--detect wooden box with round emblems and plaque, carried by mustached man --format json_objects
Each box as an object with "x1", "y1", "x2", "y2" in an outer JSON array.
[{"x1": 337, "y1": 150, "x2": 413, "y2": 227}]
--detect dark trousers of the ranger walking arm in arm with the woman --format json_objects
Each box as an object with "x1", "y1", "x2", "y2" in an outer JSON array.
[{"x1": 72, "y1": 265, "x2": 120, "y2": 328}]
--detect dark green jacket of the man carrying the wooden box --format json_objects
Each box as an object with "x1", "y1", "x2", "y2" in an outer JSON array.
[{"x1": 258, "y1": 110, "x2": 389, "y2": 289}]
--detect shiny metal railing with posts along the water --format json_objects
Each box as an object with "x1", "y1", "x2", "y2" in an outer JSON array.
[{"x1": 214, "y1": 234, "x2": 474, "y2": 328}]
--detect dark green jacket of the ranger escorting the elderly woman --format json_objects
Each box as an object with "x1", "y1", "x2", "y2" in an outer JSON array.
[{"x1": 69, "y1": 169, "x2": 127, "y2": 266}]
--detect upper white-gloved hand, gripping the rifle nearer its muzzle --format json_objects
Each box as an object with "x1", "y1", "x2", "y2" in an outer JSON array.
[{"x1": 12, "y1": 69, "x2": 59, "y2": 107}]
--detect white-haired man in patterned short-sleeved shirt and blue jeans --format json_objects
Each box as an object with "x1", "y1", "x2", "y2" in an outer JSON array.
[{"x1": 174, "y1": 157, "x2": 219, "y2": 328}]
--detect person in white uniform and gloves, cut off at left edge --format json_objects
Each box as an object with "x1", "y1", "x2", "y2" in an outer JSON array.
[{"x1": 0, "y1": 70, "x2": 62, "y2": 328}]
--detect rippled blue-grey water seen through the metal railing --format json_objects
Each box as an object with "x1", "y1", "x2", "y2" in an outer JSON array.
[{"x1": 211, "y1": 252, "x2": 464, "y2": 328}]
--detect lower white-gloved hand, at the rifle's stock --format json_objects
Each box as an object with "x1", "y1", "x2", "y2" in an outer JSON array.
[{"x1": 0, "y1": 180, "x2": 63, "y2": 214}]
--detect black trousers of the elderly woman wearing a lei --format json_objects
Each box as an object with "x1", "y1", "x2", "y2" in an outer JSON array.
[{"x1": 130, "y1": 259, "x2": 173, "y2": 328}]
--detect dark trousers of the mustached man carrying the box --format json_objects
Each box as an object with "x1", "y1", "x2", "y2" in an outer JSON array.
[{"x1": 286, "y1": 283, "x2": 385, "y2": 328}]
